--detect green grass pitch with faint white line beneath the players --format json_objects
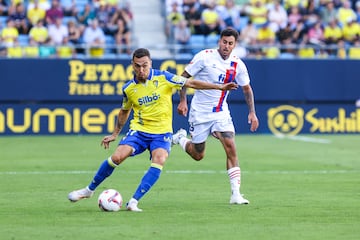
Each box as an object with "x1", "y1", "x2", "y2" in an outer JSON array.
[{"x1": 0, "y1": 135, "x2": 360, "y2": 240}]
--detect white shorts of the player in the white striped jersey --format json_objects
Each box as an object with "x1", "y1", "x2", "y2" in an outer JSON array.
[{"x1": 189, "y1": 118, "x2": 235, "y2": 143}]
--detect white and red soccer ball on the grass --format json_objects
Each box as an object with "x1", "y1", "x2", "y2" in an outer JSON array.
[{"x1": 98, "y1": 189, "x2": 122, "y2": 212}]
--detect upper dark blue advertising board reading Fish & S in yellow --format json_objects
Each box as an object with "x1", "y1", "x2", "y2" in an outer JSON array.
[{"x1": 0, "y1": 59, "x2": 360, "y2": 102}]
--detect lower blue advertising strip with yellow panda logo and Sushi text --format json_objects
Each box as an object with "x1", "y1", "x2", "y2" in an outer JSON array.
[{"x1": 0, "y1": 103, "x2": 360, "y2": 135}]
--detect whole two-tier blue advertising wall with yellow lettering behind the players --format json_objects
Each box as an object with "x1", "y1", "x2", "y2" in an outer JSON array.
[{"x1": 0, "y1": 59, "x2": 360, "y2": 135}]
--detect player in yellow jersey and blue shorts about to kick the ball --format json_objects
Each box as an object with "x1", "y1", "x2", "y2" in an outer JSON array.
[{"x1": 68, "y1": 48, "x2": 238, "y2": 212}]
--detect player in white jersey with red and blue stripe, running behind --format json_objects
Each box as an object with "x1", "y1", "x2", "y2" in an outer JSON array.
[{"x1": 173, "y1": 28, "x2": 259, "y2": 204}]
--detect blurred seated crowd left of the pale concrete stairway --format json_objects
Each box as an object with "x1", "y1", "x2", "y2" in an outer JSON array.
[{"x1": 0, "y1": 0, "x2": 133, "y2": 58}]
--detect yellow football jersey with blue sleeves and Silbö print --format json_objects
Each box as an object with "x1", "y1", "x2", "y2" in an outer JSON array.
[{"x1": 122, "y1": 69, "x2": 187, "y2": 134}]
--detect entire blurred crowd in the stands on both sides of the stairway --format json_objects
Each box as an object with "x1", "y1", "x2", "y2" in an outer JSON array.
[{"x1": 0, "y1": 0, "x2": 360, "y2": 59}]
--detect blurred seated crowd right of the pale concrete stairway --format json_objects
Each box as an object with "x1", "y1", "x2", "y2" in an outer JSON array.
[{"x1": 164, "y1": 0, "x2": 360, "y2": 59}]
